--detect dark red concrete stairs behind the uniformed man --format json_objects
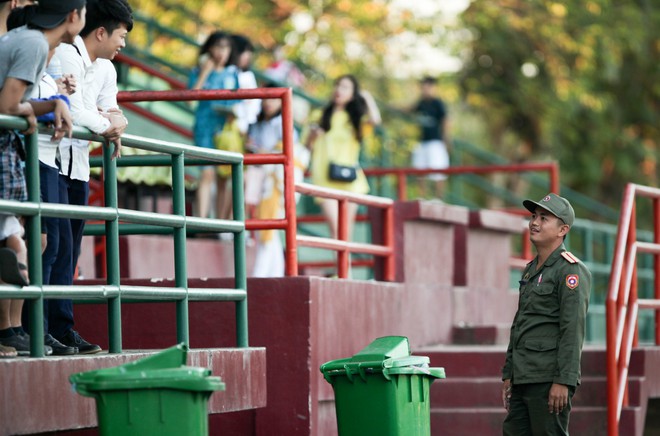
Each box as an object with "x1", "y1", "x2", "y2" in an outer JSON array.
[{"x1": 414, "y1": 345, "x2": 660, "y2": 436}]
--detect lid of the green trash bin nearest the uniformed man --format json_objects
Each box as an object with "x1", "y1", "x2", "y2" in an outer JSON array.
[{"x1": 320, "y1": 336, "x2": 445, "y2": 383}]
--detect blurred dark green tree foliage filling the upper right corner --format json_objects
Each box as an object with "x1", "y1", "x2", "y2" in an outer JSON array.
[{"x1": 460, "y1": 0, "x2": 660, "y2": 204}]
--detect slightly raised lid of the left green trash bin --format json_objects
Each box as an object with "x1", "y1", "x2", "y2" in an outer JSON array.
[{"x1": 69, "y1": 344, "x2": 225, "y2": 397}]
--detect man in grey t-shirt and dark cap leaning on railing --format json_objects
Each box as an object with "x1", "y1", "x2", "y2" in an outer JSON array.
[{"x1": 0, "y1": 0, "x2": 85, "y2": 357}]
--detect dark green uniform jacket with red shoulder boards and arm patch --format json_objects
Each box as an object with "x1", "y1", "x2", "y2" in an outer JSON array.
[{"x1": 502, "y1": 244, "x2": 591, "y2": 386}]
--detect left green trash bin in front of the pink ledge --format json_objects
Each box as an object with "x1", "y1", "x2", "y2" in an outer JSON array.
[{"x1": 69, "y1": 344, "x2": 225, "y2": 436}]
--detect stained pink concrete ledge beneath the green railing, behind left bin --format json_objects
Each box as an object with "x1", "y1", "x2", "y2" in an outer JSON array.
[{"x1": 0, "y1": 347, "x2": 267, "y2": 435}]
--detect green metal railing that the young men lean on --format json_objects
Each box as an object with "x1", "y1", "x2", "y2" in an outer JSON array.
[{"x1": 0, "y1": 115, "x2": 248, "y2": 357}]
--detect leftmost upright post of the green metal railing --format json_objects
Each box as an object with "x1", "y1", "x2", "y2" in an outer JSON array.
[{"x1": 25, "y1": 133, "x2": 44, "y2": 357}]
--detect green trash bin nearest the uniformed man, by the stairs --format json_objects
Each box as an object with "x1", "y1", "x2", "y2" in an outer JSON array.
[{"x1": 321, "y1": 336, "x2": 445, "y2": 436}]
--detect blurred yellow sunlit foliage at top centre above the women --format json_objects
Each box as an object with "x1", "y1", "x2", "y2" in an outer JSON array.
[{"x1": 131, "y1": 0, "x2": 444, "y2": 99}]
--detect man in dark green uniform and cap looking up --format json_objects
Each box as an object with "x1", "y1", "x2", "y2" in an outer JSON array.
[{"x1": 502, "y1": 194, "x2": 591, "y2": 436}]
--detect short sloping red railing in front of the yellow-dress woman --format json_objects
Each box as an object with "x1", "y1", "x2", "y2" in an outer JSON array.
[{"x1": 287, "y1": 183, "x2": 395, "y2": 281}]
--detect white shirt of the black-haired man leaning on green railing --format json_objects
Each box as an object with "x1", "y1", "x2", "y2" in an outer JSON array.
[{"x1": 55, "y1": 36, "x2": 118, "y2": 182}]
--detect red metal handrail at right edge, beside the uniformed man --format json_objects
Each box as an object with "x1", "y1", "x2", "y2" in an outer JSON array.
[{"x1": 605, "y1": 183, "x2": 660, "y2": 436}]
